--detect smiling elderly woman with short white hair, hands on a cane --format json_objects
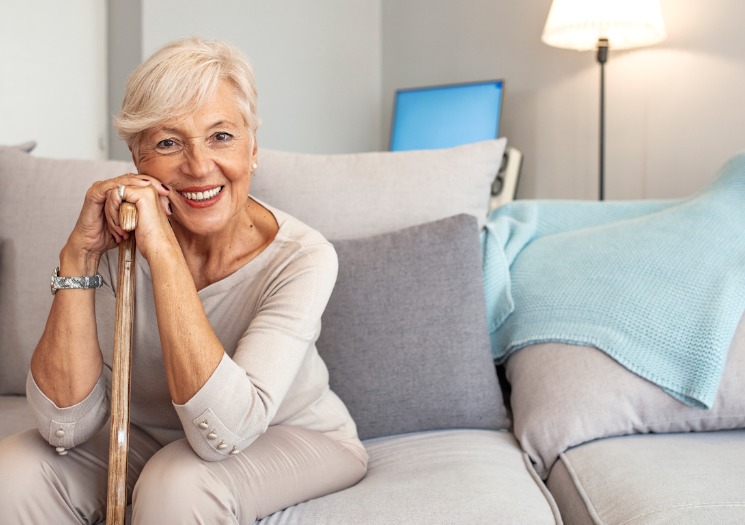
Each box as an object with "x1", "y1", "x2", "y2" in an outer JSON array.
[{"x1": 0, "y1": 35, "x2": 367, "y2": 524}]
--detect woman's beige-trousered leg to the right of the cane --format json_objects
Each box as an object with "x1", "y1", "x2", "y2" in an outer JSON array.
[{"x1": 132, "y1": 426, "x2": 366, "y2": 524}]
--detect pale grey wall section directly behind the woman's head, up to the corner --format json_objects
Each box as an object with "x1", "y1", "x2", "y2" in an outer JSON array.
[{"x1": 127, "y1": 0, "x2": 382, "y2": 153}]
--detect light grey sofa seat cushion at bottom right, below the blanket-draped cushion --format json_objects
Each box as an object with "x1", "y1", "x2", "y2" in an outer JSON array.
[{"x1": 548, "y1": 430, "x2": 745, "y2": 525}]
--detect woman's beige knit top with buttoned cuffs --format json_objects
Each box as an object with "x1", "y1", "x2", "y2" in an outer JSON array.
[{"x1": 27, "y1": 205, "x2": 364, "y2": 461}]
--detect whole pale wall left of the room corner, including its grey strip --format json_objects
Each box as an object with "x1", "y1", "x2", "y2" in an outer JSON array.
[{"x1": 0, "y1": 0, "x2": 383, "y2": 159}]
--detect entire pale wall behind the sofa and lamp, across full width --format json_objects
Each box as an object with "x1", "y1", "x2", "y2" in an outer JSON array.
[{"x1": 5, "y1": 0, "x2": 745, "y2": 199}]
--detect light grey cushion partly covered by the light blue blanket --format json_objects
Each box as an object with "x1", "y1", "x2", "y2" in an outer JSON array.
[{"x1": 507, "y1": 317, "x2": 745, "y2": 476}]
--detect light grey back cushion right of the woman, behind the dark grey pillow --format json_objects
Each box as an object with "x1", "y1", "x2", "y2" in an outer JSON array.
[{"x1": 251, "y1": 138, "x2": 507, "y2": 240}]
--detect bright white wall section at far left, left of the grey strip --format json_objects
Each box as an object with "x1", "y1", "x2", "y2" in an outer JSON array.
[{"x1": 0, "y1": 0, "x2": 108, "y2": 159}]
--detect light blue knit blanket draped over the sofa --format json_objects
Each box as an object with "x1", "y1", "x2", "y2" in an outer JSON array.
[{"x1": 482, "y1": 153, "x2": 745, "y2": 408}]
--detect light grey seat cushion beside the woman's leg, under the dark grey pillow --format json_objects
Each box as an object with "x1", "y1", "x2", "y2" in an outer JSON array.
[{"x1": 260, "y1": 430, "x2": 560, "y2": 525}]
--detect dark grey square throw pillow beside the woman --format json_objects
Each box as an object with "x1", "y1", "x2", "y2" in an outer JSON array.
[{"x1": 318, "y1": 215, "x2": 509, "y2": 438}]
